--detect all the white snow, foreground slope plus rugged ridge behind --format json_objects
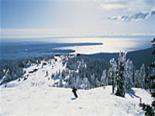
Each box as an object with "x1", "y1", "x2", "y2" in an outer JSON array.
[{"x1": 0, "y1": 57, "x2": 152, "y2": 116}]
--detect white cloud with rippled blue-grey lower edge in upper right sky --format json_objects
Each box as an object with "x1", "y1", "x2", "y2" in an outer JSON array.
[{"x1": 96, "y1": 0, "x2": 155, "y2": 21}]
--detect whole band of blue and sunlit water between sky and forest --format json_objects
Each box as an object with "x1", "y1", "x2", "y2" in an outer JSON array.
[{"x1": 0, "y1": 36, "x2": 153, "y2": 60}]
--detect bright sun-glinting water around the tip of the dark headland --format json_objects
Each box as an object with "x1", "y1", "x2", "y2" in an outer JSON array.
[{"x1": 54, "y1": 36, "x2": 153, "y2": 54}]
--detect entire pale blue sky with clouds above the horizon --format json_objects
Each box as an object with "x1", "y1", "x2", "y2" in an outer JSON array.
[{"x1": 0, "y1": 0, "x2": 155, "y2": 38}]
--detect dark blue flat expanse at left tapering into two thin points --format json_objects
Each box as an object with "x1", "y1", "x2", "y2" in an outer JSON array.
[{"x1": 0, "y1": 40, "x2": 101, "y2": 61}]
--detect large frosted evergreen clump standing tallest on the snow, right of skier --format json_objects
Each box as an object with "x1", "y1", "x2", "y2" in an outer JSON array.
[{"x1": 108, "y1": 52, "x2": 134, "y2": 97}]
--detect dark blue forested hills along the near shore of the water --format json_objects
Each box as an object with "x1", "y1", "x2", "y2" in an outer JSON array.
[{"x1": 0, "y1": 47, "x2": 153, "y2": 66}]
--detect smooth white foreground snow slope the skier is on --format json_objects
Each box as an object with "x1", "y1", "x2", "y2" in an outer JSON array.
[{"x1": 0, "y1": 86, "x2": 151, "y2": 116}]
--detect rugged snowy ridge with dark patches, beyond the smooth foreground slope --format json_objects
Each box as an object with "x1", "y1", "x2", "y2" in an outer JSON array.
[{"x1": 1, "y1": 56, "x2": 65, "y2": 87}]
